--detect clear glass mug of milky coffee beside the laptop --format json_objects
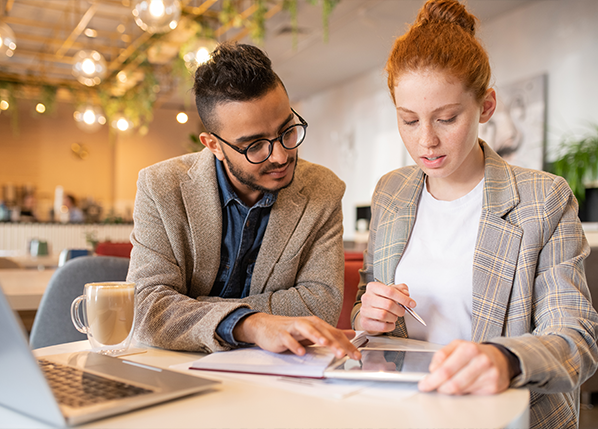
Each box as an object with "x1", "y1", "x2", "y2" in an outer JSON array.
[{"x1": 71, "y1": 282, "x2": 137, "y2": 355}]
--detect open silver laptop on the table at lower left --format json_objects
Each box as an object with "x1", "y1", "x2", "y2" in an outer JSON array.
[{"x1": 0, "y1": 287, "x2": 220, "y2": 427}]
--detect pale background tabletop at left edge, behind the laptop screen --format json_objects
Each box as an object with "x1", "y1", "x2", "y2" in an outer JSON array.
[{"x1": 0, "y1": 268, "x2": 56, "y2": 311}]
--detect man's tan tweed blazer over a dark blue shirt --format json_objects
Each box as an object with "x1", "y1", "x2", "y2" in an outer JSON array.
[{"x1": 128, "y1": 150, "x2": 345, "y2": 352}]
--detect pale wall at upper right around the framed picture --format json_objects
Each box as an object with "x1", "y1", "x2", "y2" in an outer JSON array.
[{"x1": 481, "y1": 0, "x2": 598, "y2": 157}]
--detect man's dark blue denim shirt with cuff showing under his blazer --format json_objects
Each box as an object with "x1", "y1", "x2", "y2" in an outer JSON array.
[{"x1": 210, "y1": 159, "x2": 277, "y2": 346}]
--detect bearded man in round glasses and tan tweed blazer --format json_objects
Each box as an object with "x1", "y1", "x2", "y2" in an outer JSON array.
[{"x1": 128, "y1": 44, "x2": 359, "y2": 358}]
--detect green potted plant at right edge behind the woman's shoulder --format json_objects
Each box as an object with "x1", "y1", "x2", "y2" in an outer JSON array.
[{"x1": 551, "y1": 125, "x2": 598, "y2": 222}]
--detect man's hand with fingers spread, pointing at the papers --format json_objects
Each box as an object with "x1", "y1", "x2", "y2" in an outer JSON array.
[{"x1": 233, "y1": 313, "x2": 361, "y2": 360}]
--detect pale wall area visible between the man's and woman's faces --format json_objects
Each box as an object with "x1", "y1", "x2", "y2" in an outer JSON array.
[{"x1": 297, "y1": 66, "x2": 411, "y2": 239}]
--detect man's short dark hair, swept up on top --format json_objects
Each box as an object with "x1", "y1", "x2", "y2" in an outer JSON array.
[{"x1": 193, "y1": 42, "x2": 284, "y2": 131}]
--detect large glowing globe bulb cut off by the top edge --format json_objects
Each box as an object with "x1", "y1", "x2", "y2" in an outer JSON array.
[{"x1": 131, "y1": 0, "x2": 181, "y2": 33}]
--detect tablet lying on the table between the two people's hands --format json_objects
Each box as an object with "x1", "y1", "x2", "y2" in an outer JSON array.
[{"x1": 324, "y1": 348, "x2": 434, "y2": 382}]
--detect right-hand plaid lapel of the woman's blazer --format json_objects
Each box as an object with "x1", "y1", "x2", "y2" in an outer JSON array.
[{"x1": 471, "y1": 143, "x2": 523, "y2": 342}]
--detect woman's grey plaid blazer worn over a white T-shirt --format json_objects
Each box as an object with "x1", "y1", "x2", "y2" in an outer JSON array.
[{"x1": 352, "y1": 141, "x2": 598, "y2": 428}]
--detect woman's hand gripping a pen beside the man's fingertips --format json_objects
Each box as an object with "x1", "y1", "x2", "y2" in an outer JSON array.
[{"x1": 355, "y1": 282, "x2": 416, "y2": 334}]
